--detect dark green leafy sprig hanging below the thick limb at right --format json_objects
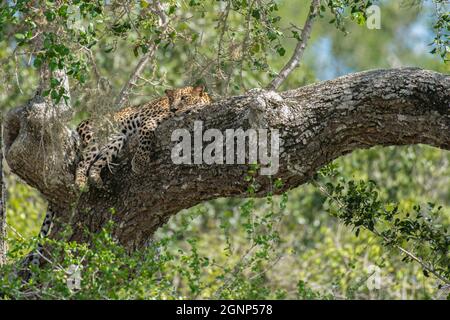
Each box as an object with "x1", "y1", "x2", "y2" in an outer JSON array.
[{"x1": 319, "y1": 168, "x2": 450, "y2": 285}]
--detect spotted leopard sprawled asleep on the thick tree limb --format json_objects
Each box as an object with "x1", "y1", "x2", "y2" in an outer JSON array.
[{"x1": 75, "y1": 85, "x2": 213, "y2": 190}]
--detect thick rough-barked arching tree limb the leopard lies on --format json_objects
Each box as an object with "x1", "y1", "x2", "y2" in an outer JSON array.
[{"x1": 4, "y1": 68, "x2": 450, "y2": 250}]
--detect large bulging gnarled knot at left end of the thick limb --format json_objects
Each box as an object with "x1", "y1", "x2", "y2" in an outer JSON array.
[{"x1": 4, "y1": 95, "x2": 78, "y2": 203}]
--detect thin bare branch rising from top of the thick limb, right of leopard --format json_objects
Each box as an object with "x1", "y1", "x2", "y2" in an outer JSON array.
[{"x1": 266, "y1": 0, "x2": 320, "y2": 90}]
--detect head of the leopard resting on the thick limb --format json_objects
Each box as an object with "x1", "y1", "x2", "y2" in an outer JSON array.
[{"x1": 165, "y1": 86, "x2": 212, "y2": 112}]
